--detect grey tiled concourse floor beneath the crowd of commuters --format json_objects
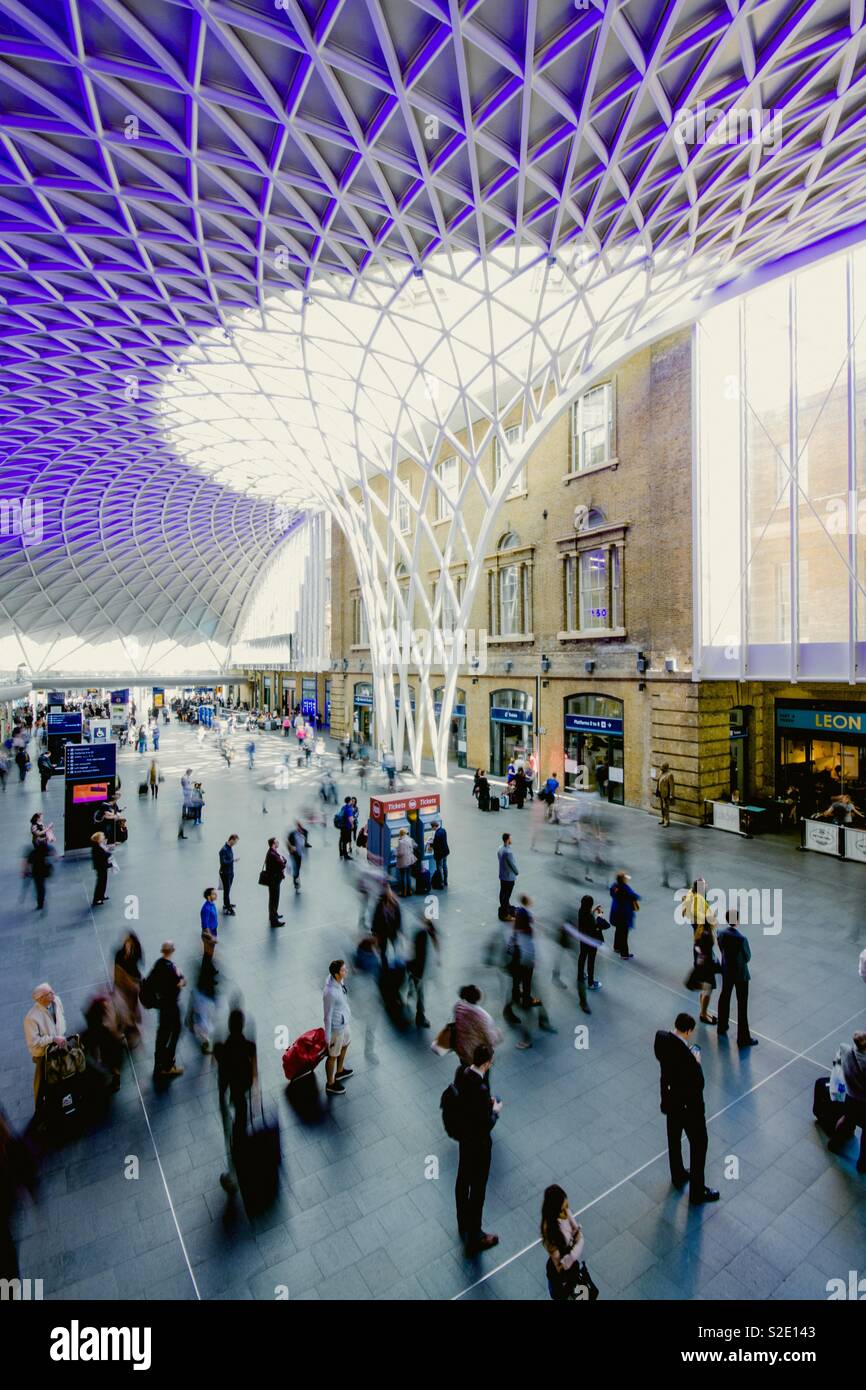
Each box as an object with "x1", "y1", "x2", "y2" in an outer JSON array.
[{"x1": 0, "y1": 723, "x2": 866, "y2": 1301}]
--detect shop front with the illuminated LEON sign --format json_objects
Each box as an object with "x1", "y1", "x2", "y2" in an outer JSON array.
[{"x1": 776, "y1": 699, "x2": 866, "y2": 817}]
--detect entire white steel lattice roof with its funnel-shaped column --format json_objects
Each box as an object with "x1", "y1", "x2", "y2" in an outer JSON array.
[{"x1": 0, "y1": 0, "x2": 866, "y2": 773}]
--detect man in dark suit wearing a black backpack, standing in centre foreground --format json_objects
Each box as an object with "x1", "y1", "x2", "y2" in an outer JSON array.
[{"x1": 453, "y1": 1045, "x2": 502, "y2": 1258}]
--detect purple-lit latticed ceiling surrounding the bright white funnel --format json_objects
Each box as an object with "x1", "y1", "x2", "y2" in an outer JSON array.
[{"x1": 0, "y1": 0, "x2": 866, "y2": 642}]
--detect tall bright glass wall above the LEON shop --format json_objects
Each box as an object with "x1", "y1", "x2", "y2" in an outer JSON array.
[{"x1": 695, "y1": 249, "x2": 866, "y2": 680}]
